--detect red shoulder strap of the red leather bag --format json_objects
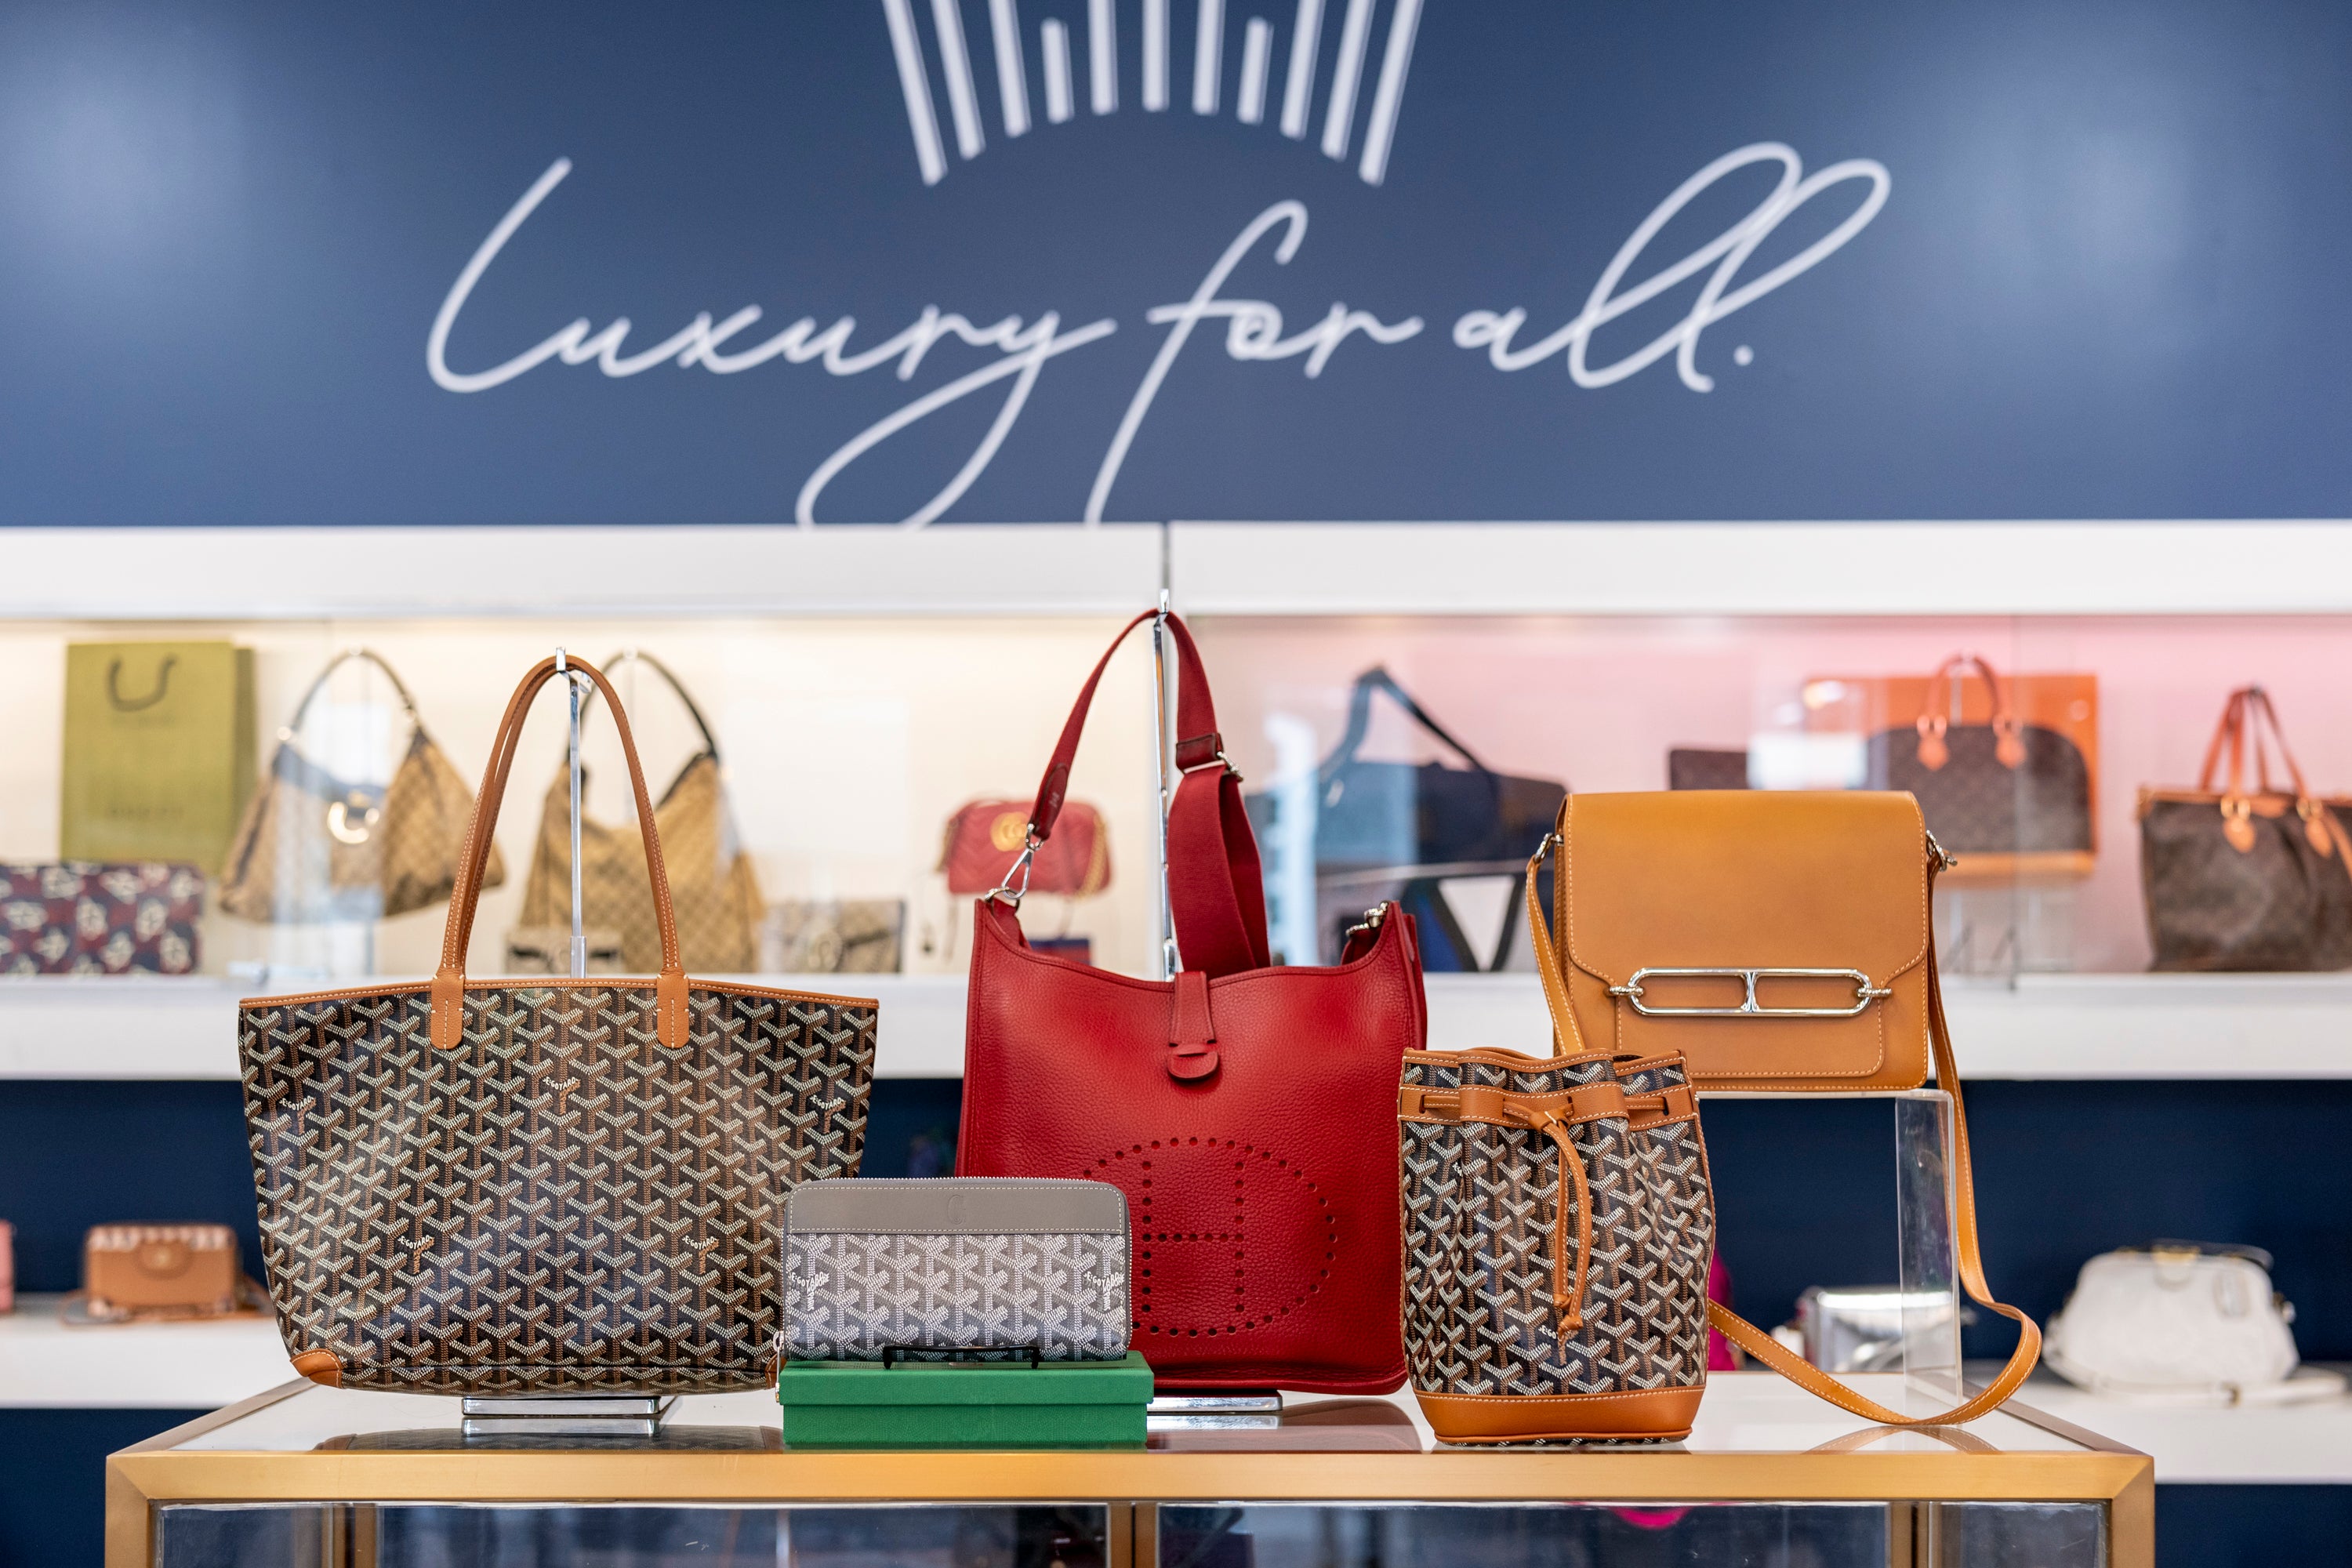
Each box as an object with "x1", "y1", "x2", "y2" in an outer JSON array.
[{"x1": 1028, "y1": 612, "x2": 1270, "y2": 975}]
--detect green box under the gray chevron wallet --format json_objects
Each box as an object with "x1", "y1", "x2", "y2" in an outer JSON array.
[{"x1": 776, "y1": 1352, "x2": 1152, "y2": 1448}]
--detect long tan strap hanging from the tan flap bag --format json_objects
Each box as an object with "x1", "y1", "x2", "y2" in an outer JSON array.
[{"x1": 1526, "y1": 832, "x2": 2042, "y2": 1427}]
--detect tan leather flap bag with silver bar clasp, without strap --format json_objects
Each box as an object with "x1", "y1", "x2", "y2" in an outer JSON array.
[{"x1": 1555, "y1": 789, "x2": 1940, "y2": 1093}]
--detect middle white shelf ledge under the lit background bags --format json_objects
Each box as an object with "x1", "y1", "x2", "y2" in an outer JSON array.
[{"x1": 0, "y1": 973, "x2": 2352, "y2": 1079}]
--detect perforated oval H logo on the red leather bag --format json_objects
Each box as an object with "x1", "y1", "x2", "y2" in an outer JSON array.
[{"x1": 1089, "y1": 1138, "x2": 1338, "y2": 1340}]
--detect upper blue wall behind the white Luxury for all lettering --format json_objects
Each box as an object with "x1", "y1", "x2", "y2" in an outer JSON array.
[{"x1": 0, "y1": 0, "x2": 2352, "y2": 524}]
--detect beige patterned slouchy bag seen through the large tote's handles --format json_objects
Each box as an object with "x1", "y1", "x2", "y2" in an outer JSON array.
[{"x1": 515, "y1": 654, "x2": 762, "y2": 975}]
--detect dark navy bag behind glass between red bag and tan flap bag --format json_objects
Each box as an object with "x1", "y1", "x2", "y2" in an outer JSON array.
[{"x1": 1247, "y1": 668, "x2": 1566, "y2": 971}]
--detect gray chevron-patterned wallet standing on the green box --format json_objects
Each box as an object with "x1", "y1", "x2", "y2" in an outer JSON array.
[{"x1": 783, "y1": 1175, "x2": 1131, "y2": 1361}]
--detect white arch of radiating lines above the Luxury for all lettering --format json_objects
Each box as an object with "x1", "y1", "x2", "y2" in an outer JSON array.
[{"x1": 882, "y1": 0, "x2": 1421, "y2": 186}]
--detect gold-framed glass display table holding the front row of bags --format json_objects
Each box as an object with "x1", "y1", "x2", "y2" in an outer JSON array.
[{"x1": 106, "y1": 1373, "x2": 2154, "y2": 1568}]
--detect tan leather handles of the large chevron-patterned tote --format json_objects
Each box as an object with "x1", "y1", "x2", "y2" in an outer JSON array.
[{"x1": 433, "y1": 659, "x2": 687, "y2": 1051}]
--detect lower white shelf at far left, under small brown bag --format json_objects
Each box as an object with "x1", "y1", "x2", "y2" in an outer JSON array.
[{"x1": 0, "y1": 1295, "x2": 292, "y2": 1410}]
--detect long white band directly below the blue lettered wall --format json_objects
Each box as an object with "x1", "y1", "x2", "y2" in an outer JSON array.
[{"x1": 0, "y1": 520, "x2": 2352, "y2": 621}]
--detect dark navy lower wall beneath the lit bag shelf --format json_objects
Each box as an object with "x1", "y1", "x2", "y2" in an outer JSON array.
[{"x1": 0, "y1": 1079, "x2": 2352, "y2": 1566}]
